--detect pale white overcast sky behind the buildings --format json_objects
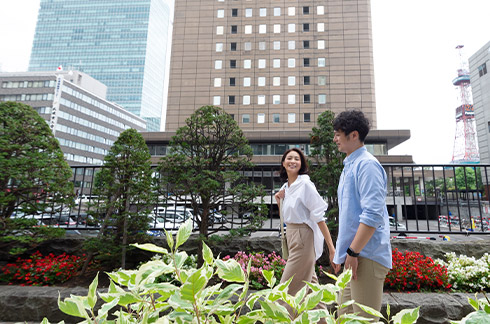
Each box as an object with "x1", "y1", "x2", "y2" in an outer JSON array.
[{"x1": 0, "y1": 0, "x2": 490, "y2": 164}]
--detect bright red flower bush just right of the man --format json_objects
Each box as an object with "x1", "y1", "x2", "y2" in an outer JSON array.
[{"x1": 385, "y1": 249, "x2": 451, "y2": 291}]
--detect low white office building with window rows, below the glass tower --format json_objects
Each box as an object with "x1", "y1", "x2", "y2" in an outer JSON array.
[{"x1": 0, "y1": 71, "x2": 146, "y2": 165}]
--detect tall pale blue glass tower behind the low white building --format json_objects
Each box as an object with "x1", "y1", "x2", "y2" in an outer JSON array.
[{"x1": 29, "y1": 0, "x2": 170, "y2": 131}]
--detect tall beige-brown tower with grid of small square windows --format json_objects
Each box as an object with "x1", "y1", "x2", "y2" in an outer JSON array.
[{"x1": 166, "y1": 0, "x2": 376, "y2": 132}]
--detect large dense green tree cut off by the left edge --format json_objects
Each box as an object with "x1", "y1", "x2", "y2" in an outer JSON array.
[{"x1": 0, "y1": 102, "x2": 74, "y2": 254}]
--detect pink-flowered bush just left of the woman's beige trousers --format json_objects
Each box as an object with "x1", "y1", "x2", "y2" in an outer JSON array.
[{"x1": 223, "y1": 251, "x2": 286, "y2": 289}]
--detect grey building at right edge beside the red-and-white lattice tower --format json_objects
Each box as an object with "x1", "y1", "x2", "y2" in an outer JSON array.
[{"x1": 469, "y1": 42, "x2": 490, "y2": 164}]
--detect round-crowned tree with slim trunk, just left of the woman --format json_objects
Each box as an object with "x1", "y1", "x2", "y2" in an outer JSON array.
[{"x1": 159, "y1": 106, "x2": 267, "y2": 264}]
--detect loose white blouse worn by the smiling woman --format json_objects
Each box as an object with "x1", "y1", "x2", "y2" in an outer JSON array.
[{"x1": 281, "y1": 174, "x2": 328, "y2": 260}]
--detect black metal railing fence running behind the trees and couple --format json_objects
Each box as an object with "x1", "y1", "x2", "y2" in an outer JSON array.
[{"x1": 15, "y1": 164, "x2": 490, "y2": 235}]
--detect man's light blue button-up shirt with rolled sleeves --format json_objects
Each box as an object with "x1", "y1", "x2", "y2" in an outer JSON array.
[{"x1": 334, "y1": 146, "x2": 391, "y2": 269}]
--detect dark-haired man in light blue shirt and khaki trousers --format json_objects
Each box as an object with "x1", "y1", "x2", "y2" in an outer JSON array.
[{"x1": 333, "y1": 111, "x2": 391, "y2": 320}]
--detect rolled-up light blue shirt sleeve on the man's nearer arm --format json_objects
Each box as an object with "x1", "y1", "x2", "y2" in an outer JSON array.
[{"x1": 357, "y1": 160, "x2": 386, "y2": 228}]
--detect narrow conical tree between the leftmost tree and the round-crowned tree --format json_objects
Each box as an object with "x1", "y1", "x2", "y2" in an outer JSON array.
[{"x1": 82, "y1": 129, "x2": 154, "y2": 273}]
